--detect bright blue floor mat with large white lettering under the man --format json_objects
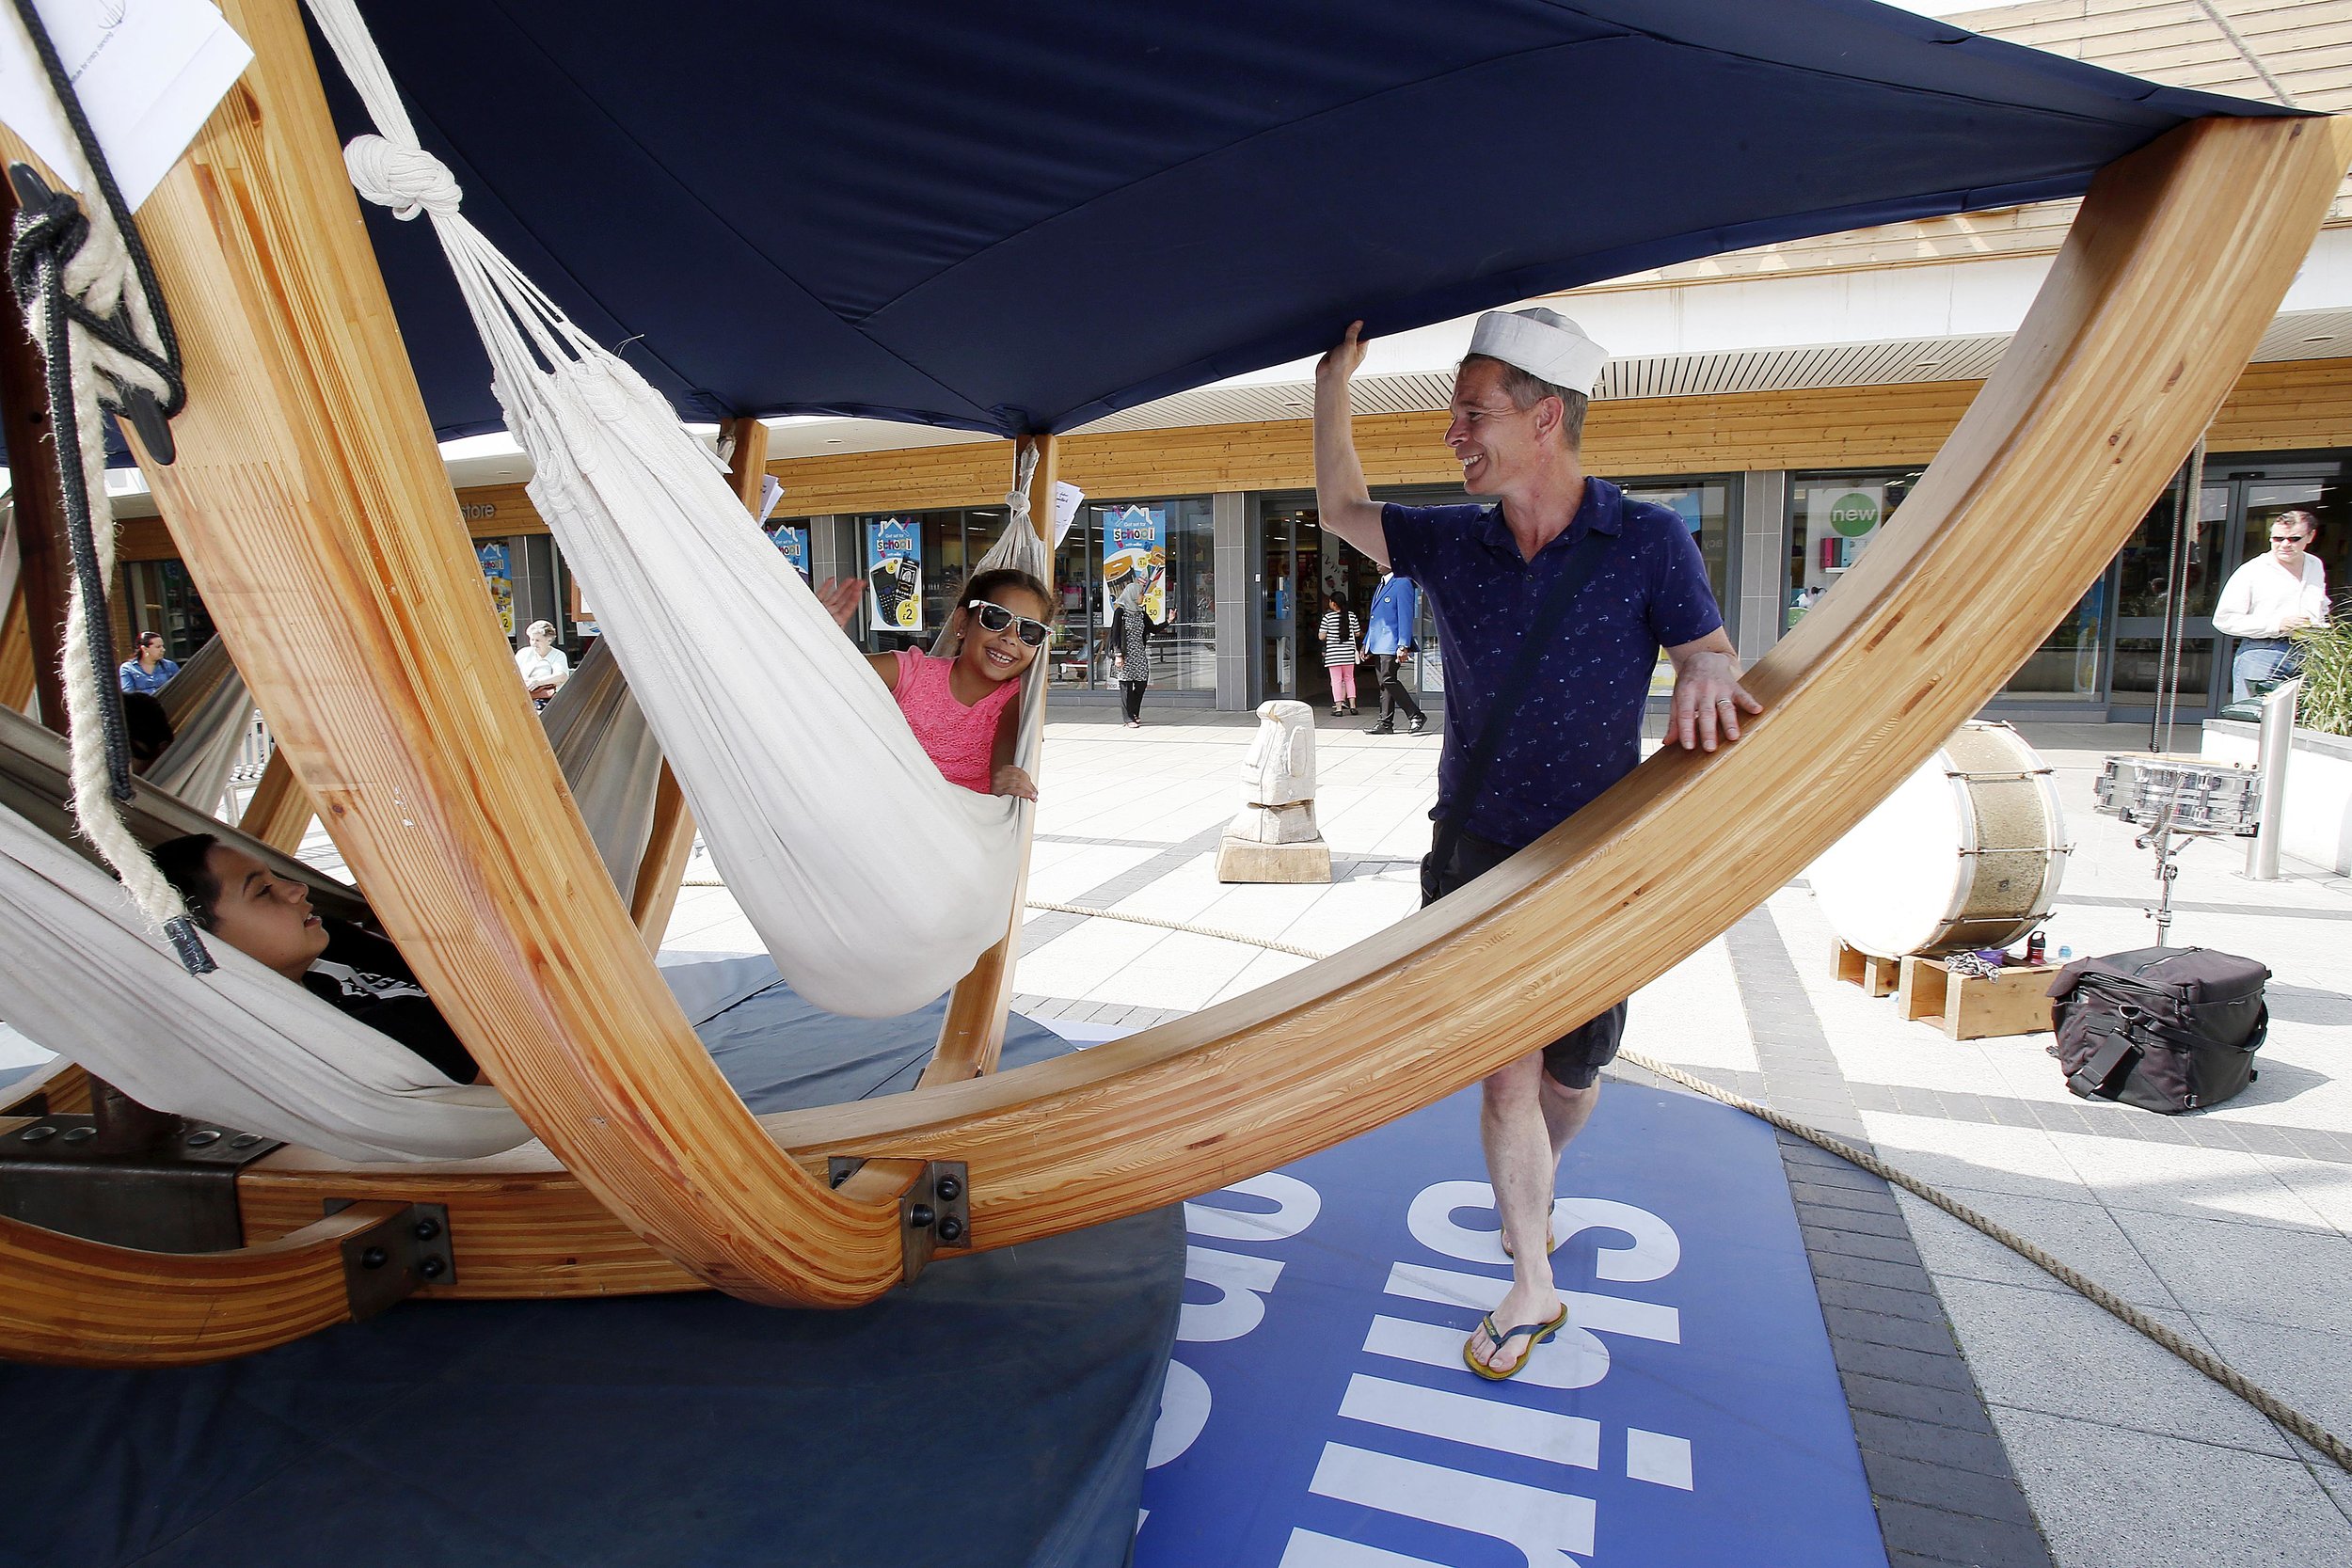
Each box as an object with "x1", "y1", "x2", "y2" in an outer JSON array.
[{"x1": 1136, "y1": 1082, "x2": 1886, "y2": 1568}]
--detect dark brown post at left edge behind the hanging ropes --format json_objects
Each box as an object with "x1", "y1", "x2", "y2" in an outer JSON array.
[{"x1": 0, "y1": 179, "x2": 73, "y2": 734}]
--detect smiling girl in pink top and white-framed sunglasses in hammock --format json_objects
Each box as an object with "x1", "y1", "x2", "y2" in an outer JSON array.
[{"x1": 817, "y1": 566, "x2": 1054, "y2": 800}]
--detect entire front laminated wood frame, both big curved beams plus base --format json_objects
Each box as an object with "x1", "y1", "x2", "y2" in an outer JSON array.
[{"x1": 0, "y1": 0, "x2": 2352, "y2": 1364}]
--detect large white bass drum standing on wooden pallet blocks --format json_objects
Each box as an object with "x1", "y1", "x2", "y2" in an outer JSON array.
[{"x1": 1806, "y1": 721, "x2": 2070, "y2": 959}]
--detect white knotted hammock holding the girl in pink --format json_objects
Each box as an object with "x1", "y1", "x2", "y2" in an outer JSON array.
[{"x1": 310, "y1": 0, "x2": 1047, "y2": 1018}]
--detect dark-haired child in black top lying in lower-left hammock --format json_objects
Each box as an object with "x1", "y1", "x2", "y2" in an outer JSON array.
[{"x1": 155, "y1": 832, "x2": 483, "y2": 1084}]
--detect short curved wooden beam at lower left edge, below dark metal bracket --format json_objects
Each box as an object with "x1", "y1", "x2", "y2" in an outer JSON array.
[{"x1": 0, "y1": 1204, "x2": 400, "y2": 1366}]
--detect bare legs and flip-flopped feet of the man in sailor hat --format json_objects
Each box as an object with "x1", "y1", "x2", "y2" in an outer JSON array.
[{"x1": 1472, "y1": 1051, "x2": 1599, "y2": 1370}]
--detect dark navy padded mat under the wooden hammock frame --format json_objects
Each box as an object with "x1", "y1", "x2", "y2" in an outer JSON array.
[{"x1": 0, "y1": 959, "x2": 1184, "y2": 1568}]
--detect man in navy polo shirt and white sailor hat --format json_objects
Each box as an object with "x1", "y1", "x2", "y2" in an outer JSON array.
[{"x1": 1315, "y1": 310, "x2": 1762, "y2": 1378}]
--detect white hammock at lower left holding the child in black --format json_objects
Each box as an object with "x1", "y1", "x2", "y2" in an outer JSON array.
[{"x1": 0, "y1": 809, "x2": 532, "y2": 1159}]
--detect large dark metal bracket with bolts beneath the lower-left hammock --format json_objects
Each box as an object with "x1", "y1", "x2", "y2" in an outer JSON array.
[{"x1": 0, "y1": 1115, "x2": 285, "y2": 1253}]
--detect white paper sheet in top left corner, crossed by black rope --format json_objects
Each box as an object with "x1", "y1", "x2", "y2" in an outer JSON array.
[{"x1": 0, "y1": 0, "x2": 254, "y2": 212}]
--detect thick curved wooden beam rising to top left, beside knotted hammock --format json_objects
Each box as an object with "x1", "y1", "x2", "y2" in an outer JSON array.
[{"x1": 61, "y1": 0, "x2": 903, "y2": 1305}]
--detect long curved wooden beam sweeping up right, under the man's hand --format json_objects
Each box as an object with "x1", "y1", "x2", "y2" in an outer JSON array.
[{"x1": 739, "y1": 119, "x2": 2352, "y2": 1248}]
